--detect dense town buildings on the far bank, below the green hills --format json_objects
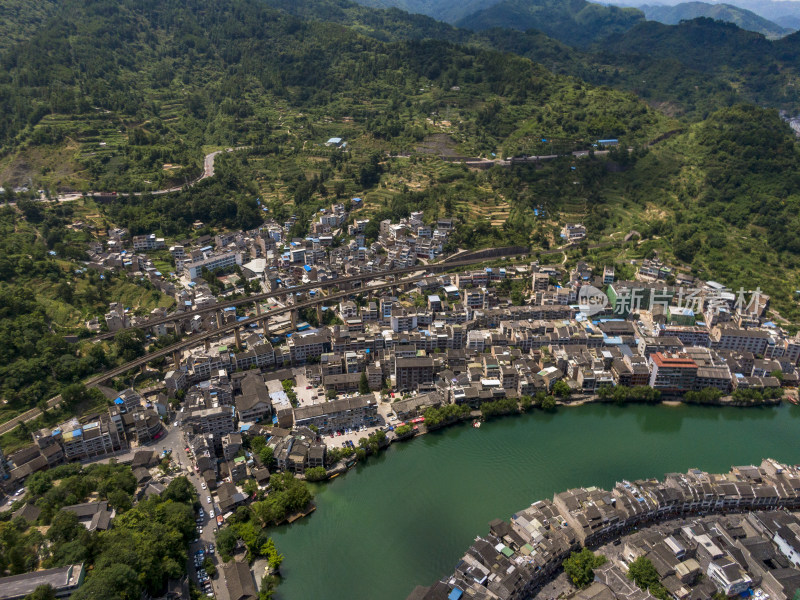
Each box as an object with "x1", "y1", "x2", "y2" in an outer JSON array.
[{"x1": 10, "y1": 210, "x2": 800, "y2": 492}]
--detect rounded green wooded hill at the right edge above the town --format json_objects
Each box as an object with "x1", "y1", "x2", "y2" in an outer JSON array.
[{"x1": 597, "y1": 105, "x2": 800, "y2": 315}]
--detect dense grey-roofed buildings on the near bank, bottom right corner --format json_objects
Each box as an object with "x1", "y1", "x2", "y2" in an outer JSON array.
[{"x1": 409, "y1": 459, "x2": 800, "y2": 600}]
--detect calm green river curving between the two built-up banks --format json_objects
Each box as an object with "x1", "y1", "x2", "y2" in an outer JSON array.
[{"x1": 273, "y1": 404, "x2": 800, "y2": 600}]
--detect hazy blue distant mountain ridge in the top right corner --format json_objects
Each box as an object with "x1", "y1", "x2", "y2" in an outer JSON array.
[{"x1": 639, "y1": 2, "x2": 794, "y2": 39}]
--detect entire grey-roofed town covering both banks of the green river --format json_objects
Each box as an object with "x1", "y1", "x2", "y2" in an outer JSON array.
[{"x1": 0, "y1": 198, "x2": 800, "y2": 600}]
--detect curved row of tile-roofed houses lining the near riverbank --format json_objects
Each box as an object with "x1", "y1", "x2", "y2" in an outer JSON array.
[{"x1": 408, "y1": 459, "x2": 800, "y2": 600}]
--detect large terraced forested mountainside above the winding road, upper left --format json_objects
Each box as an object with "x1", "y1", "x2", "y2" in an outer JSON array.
[{"x1": 0, "y1": 0, "x2": 672, "y2": 189}]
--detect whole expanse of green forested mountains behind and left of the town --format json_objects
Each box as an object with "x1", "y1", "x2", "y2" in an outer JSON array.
[{"x1": 0, "y1": 0, "x2": 800, "y2": 411}]
